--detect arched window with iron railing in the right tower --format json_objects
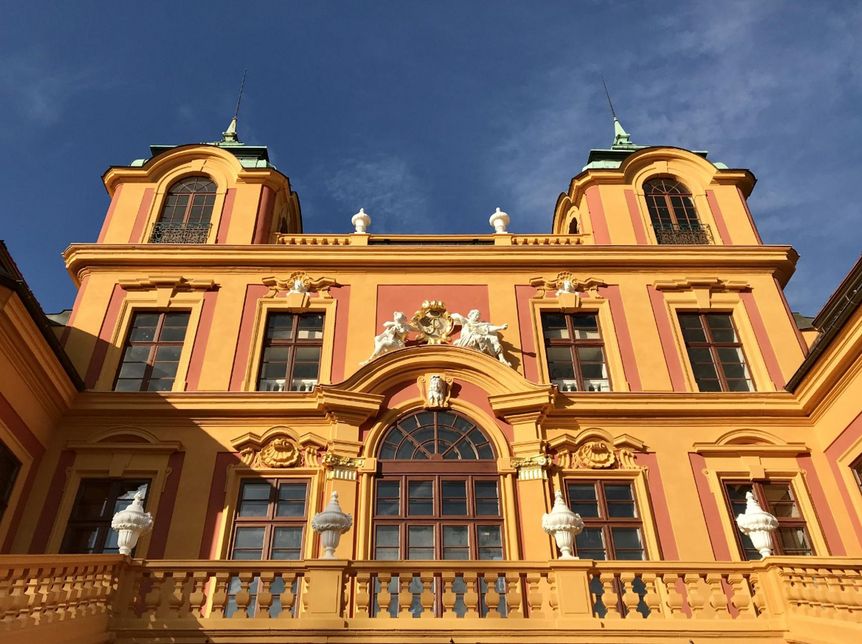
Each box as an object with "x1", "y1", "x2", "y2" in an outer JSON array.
[{"x1": 644, "y1": 177, "x2": 712, "y2": 244}]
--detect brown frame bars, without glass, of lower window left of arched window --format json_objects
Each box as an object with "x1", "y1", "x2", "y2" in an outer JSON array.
[{"x1": 228, "y1": 477, "x2": 311, "y2": 561}]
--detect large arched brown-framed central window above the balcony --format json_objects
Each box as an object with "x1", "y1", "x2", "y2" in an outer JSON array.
[{"x1": 372, "y1": 411, "x2": 503, "y2": 560}]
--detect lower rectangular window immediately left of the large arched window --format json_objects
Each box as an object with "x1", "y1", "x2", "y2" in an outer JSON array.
[{"x1": 230, "y1": 479, "x2": 308, "y2": 560}]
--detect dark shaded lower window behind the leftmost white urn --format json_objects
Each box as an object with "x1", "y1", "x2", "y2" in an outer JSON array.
[{"x1": 61, "y1": 479, "x2": 150, "y2": 554}]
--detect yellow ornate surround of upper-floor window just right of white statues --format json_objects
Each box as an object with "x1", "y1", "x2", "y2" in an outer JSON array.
[{"x1": 530, "y1": 272, "x2": 628, "y2": 395}]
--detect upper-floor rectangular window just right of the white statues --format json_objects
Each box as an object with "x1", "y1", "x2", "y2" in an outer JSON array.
[{"x1": 542, "y1": 312, "x2": 611, "y2": 391}]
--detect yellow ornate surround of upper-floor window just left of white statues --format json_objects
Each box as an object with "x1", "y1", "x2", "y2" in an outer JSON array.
[{"x1": 242, "y1": 272, "x2": 338, "y2": 393}]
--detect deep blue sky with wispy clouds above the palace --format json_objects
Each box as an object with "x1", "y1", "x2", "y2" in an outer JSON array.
[{"x1": 0, "y1": 0, "x2": 862, "y2": 313}]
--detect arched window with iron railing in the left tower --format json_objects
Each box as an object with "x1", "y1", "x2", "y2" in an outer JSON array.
[{"x1": 150, "y1": 176, "x2": 216, "y2": 244}]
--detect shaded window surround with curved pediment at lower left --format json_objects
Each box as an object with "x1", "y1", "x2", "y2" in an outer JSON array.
[{"x1": 45, "y1": 427, "x2": 184, "y2": 557}]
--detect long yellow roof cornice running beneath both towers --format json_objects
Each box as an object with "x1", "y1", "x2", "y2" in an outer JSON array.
[{"x1": 64, "y1": 244, "x2": 798, "y2": 284}]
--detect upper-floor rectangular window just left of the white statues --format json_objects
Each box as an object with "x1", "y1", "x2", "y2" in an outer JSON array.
[{"x1": 257, "y1": 313, "x2": 323, "y2": 391}]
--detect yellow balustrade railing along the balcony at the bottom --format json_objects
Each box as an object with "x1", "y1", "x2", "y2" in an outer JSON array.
[{"x1": 0, "y1": 555, "x2": 862, "y2": 642}]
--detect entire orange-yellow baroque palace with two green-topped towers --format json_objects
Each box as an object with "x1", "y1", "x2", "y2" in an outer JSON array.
[{"x1": 0, "y1": 121, "x2": 862, "y2": 644}]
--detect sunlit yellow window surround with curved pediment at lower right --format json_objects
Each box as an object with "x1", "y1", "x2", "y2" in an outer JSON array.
[{"x1": 692, "y1": 430, "x2": 829, "y2": 561}]
